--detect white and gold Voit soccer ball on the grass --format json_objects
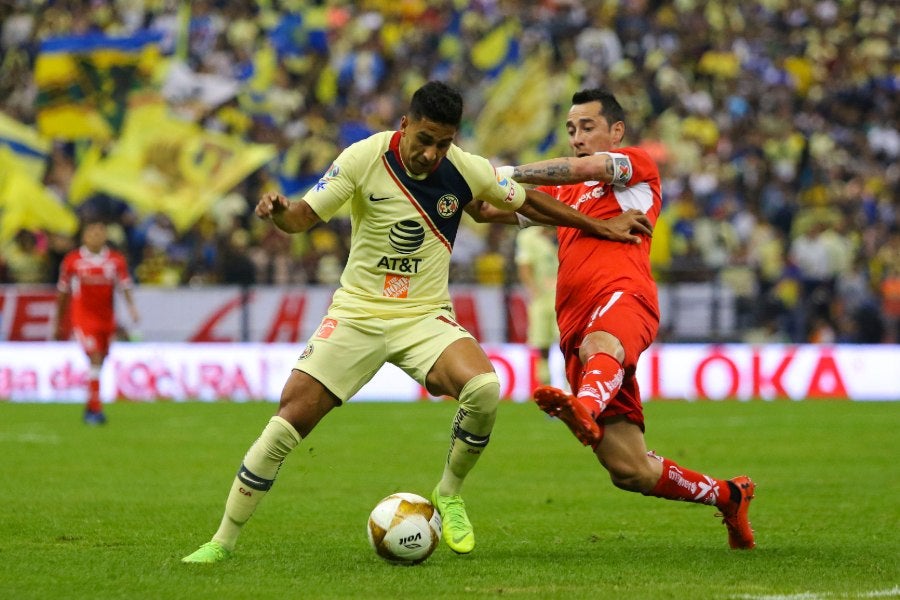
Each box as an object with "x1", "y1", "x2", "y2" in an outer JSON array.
[{"x1": 367, "y1": 492, "x2": 441, "y2": 565}]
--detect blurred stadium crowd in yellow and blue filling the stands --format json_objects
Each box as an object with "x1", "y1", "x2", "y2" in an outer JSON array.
[{"x1": 0, "y1": 0, "x2": 900, "y2": 343}]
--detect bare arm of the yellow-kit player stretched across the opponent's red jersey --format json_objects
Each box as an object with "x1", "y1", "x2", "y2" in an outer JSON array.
[{"x1": 517, "y1": 190, "x2": 653, "y2": 244}]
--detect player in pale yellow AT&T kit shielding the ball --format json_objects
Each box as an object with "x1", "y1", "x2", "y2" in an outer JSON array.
[{"x1": 182, "y1": 81, "x2": 649, "y2": 563}]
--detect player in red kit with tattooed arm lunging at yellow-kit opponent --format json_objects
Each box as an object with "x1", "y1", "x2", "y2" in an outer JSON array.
[{"x1": 491, "y1": 89, "x2": 755, "y2": 549}]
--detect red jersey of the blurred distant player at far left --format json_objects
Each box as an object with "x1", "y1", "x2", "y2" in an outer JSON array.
[{"x1": 57, "y1": 246, "x2": 132, "y2": 332}]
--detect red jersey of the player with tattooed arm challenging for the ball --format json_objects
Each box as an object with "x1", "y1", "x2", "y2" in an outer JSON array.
[{"x1": 538, "y1": 147, "x2": 662, "y2": 340}]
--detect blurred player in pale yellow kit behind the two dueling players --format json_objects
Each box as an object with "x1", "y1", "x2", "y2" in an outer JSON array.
[{"x1": 515, "y1": 227, "x2": 559, "y2": 385}]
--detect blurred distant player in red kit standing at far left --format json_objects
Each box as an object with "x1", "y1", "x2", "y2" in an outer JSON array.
[{"x1": 55, "y1": 221, "x2": 140, "y2": 425}]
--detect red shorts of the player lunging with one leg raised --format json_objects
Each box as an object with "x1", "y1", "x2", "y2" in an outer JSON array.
[{"x1": 560, "y1": 292, "x2": 659, "y2": 430}]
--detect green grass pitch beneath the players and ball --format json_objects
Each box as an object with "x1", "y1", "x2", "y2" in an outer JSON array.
[{"x1": 0, "y1": 401, "x2": 900, "y2": 600}]
